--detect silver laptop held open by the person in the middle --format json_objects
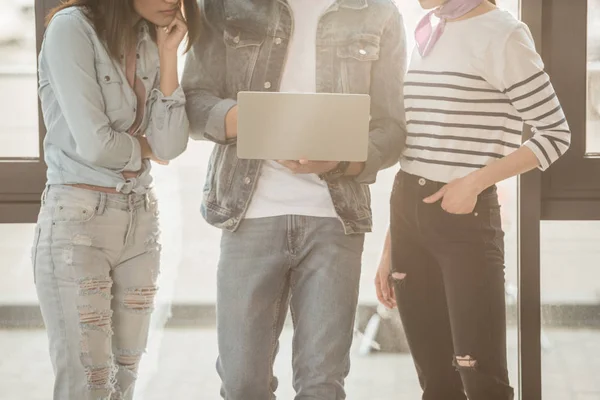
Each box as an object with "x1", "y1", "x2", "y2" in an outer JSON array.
[{"x1": 237, "y1": 92, "x2": 371, "y2": 161}]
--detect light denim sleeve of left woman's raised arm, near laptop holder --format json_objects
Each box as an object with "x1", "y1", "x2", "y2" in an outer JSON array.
[{"x1": 146, "y1": 86, "x2": 190, "y2": 161}]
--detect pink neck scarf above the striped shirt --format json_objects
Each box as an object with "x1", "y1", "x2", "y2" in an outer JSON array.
[{"x1": 415, "y1": 0, "x2": 484, "y2": 57}]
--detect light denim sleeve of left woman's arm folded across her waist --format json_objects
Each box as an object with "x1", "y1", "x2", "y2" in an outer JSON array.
[{"x1": 40, "y1": 14, "x2": 142, "y2": 171}]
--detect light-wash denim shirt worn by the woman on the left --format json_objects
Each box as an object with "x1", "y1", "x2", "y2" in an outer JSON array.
[{"x1": 39, "y1": 7, "x2": 189, "y2": 193}]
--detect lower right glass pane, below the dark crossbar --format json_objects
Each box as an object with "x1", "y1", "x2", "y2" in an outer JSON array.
[{"x1": 541, "y1": 221, "x2": 600, "y2": 400}]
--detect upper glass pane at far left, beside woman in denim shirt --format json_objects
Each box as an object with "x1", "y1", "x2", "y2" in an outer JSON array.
[{"x1": 0, "y1": 0, "x2": 39, "y2": 158}]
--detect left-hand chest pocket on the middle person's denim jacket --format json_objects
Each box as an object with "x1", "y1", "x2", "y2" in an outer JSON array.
[{"x1": 223, "y1": 27, "x2": 264, "y2": 93}]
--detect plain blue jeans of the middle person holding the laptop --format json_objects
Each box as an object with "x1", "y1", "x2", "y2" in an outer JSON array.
[{"x1": 217, "y1": 216, "x2": 364, "y2": 400}]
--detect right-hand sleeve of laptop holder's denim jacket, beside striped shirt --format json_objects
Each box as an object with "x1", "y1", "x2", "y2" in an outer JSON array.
[{"x1": 355, "y1": 7, "x2": 407, "y2": 184}]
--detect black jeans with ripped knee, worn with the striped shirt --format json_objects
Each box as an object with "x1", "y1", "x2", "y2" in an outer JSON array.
[{"x1": 390, "y1": 171, "x2": 514, "y2": 400}]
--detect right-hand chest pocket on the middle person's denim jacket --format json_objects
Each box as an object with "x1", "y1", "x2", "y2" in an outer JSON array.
[{"x1": 335, "y1": 34, "x2": 380, "y2": 94}]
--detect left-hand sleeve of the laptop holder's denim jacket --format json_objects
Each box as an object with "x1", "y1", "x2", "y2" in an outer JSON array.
[{"x1": 182, "y1": 1, "x2": 236, "y2": 145}]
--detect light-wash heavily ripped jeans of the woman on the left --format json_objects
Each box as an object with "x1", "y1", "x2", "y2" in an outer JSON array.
[{"x1": 32, "y1": 186, "x2": 160, "y2": 400}]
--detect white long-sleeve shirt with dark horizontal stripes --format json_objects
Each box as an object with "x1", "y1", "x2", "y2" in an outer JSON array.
[{"x1": 400, "y1": 10, "x2": 571, "y2": 182}]
